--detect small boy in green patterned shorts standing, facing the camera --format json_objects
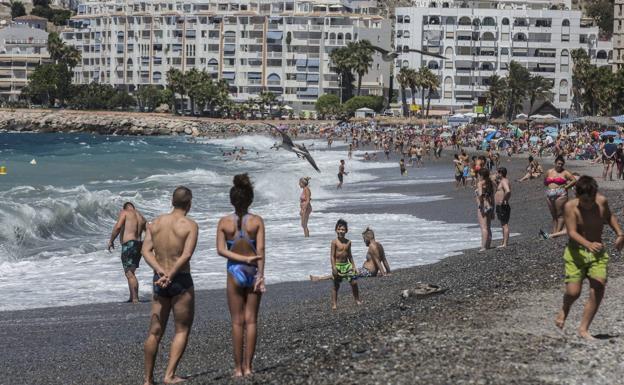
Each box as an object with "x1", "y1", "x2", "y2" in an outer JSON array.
[{"x1": 331, "y1": 219, "x2": 362, "y2": 310}]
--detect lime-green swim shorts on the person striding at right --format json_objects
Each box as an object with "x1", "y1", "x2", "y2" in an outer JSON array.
[{"x1": 563, "y1": 245, "x2": 609, "y2": 283}]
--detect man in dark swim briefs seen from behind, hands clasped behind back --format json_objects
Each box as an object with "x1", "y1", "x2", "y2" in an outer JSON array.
[{"x1": 143, "y1": 187, "x2": 198, "y2": 385}]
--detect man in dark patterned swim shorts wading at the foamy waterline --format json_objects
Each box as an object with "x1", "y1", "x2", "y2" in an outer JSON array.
[{"x1": 108, "y1": 202, "x2": 145, "y2": 303}]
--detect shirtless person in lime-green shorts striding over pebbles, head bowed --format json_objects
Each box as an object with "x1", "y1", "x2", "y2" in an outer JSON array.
[{"x1": 555, "y1": 175, "x2": 624, "y2": 339}]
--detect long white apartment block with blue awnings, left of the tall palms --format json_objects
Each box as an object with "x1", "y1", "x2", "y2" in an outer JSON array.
[{"x1": 61, "y1": 0, "x2": 392, "y2": 111}]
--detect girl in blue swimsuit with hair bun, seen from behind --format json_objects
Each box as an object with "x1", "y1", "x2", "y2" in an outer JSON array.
[{"x1": 217, "y1": 174, "x2": 265, "y2": 377}]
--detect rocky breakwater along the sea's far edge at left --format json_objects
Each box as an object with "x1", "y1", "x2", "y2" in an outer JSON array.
[{"x1": 0, "y1": 109, "x2": 280, "y2": 136}]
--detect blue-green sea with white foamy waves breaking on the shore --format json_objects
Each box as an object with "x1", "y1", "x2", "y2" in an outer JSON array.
[{"x1": 0, "y1": 133, "x2": 488, "y2": 311}]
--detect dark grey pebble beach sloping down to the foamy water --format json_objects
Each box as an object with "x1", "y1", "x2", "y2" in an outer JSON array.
[{"x1": 0, "y1": 150, "x2": 624, "y2": 384}]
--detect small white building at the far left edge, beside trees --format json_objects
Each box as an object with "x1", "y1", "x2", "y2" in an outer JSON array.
[{"x1": 0, "y1": 21, "x2": 50, "y2": 101}]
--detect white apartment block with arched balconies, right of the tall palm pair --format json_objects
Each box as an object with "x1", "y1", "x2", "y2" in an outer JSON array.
[{"x1": 394, "y1": 0, "x2": 612, "y2": 115}]
